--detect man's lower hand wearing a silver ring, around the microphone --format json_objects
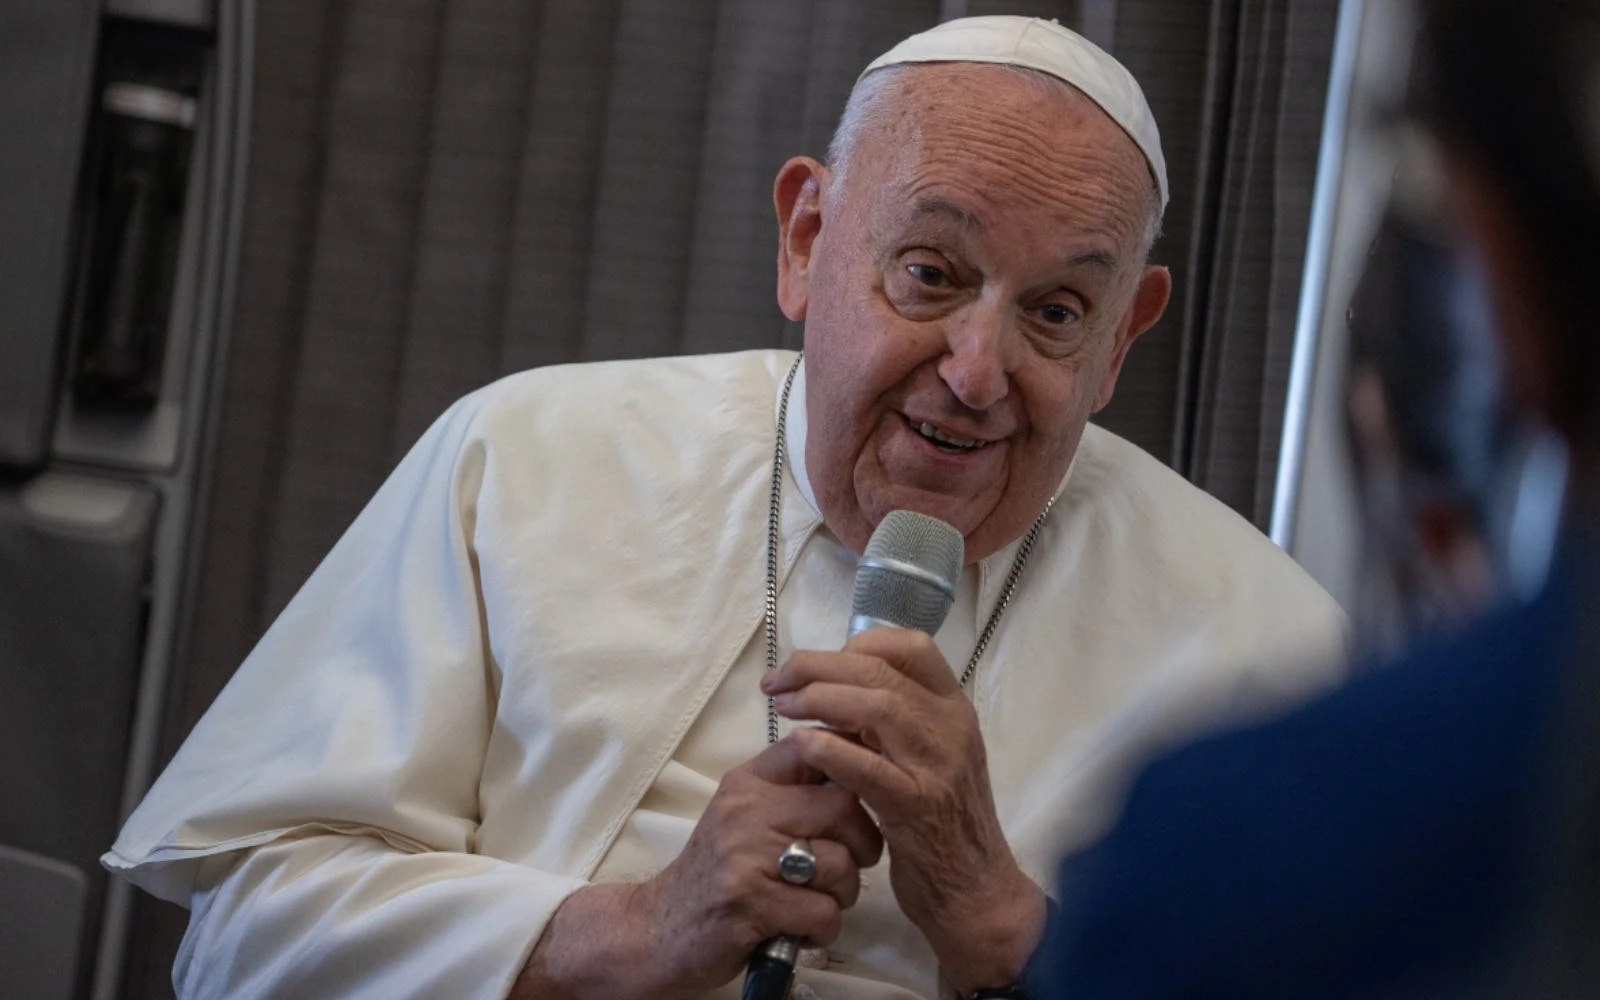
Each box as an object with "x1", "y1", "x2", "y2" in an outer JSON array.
[{"x1": 512, "y1": 739, "x2": 883, "y2": 998}]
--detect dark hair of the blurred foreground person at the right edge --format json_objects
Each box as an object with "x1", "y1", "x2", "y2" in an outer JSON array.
[{"x1": 1414, "y1": 0, "x2": 1600, "y2": 432}]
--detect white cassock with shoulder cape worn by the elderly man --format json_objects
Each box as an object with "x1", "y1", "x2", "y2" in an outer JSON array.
[{"x1": 104, "y1": 352, "x2": 1342, "y2": 1000}]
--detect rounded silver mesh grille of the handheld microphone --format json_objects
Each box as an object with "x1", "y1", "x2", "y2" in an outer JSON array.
[{"x1": 851, "y1": 510, "x2": 966, "y2": 635}]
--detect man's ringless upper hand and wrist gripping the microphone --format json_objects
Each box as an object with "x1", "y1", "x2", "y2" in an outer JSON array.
[{"x1": 762, "y1": 629, "x2": 1045, "y2": 994}]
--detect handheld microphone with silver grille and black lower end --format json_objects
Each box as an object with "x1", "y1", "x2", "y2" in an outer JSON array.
[{"x1": 742, "y1": 510, "x2": 966, "y2": 1000}]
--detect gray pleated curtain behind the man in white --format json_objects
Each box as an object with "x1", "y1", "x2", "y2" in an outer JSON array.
[{"x1": 131, "y1": 0, "x2": 1338, "y2": 995}]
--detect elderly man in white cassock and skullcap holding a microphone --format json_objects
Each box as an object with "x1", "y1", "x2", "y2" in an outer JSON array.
[{"x1": 107, "y1": 18, "x2": 1341, "y2": 1000}]
